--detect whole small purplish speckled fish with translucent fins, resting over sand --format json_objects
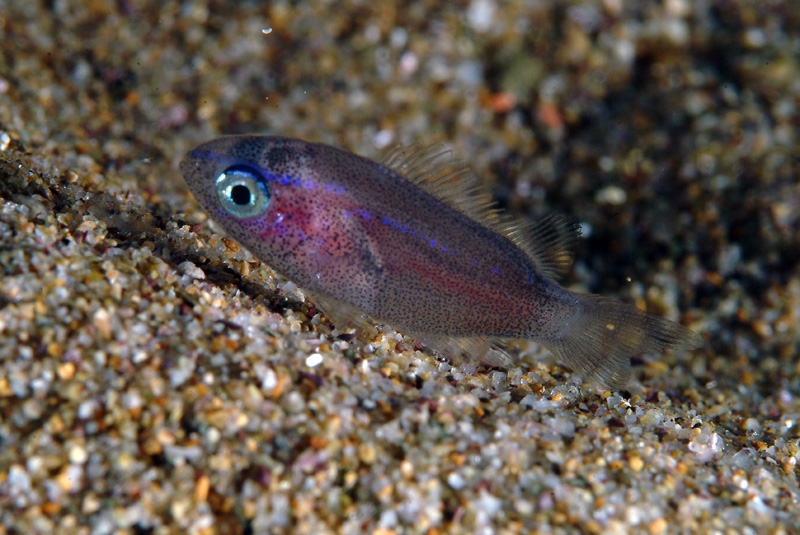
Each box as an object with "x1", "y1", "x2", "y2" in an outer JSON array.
[{"x1": 179, "y1": 135, "x2": 703, "y2": 389}]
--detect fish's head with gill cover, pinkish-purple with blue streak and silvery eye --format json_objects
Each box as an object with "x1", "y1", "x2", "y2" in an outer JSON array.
[{"x1": 180, "y1": 136, "x2": 382, "y2": 287}]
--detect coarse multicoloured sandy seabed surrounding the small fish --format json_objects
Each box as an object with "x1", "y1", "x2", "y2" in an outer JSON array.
[{"x1": 0, "y1": 0, "x2": 800, "y2": 535}]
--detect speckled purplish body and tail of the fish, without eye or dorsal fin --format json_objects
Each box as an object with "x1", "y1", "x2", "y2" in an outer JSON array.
[{"x1": 181, "y1": 136, "x2": 702, "y2": 386}]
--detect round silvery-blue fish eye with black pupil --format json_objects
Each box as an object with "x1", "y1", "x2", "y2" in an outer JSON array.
[{"x1": 216, "y1": 166, "x2": 270, "y2": 219}]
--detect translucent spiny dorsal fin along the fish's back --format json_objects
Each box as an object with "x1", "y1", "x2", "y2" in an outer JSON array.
[{"x1": 381, "y1": 143, "x2": 580, "y2": 280}]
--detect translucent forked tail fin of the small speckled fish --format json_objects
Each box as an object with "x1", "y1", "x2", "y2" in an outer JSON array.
[{"x1": 543, "y1": 294, "x2": 703, "y2": 388}]
